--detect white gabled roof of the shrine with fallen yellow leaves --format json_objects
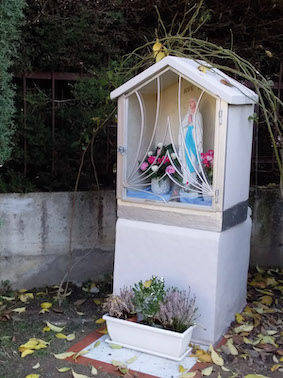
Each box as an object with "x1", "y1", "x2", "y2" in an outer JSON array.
[{"x1": 110, "y1": 56, "x2": 258, "y2": 104}]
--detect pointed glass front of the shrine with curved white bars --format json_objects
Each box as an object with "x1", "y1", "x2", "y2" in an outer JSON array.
[{"x1": 124, "y1": 70, "x2": 216, "y2": 206}]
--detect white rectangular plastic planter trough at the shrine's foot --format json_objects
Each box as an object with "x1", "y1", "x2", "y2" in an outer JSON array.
[{"x1": 103, "y1": 315, "x2": 194, "y2": 361}]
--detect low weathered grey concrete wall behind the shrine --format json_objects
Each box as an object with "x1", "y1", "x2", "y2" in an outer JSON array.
[{"x1": 0, "y1": 189, "x2": 283, "y2": 289}]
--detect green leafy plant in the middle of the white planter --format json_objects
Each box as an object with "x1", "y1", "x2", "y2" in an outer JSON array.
[{"x1": 133, "y1": 276, "x2": 166, "y2": 324}]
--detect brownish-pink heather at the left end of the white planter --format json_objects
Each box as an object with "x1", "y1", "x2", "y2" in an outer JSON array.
[{"x1": 103, "y1": 288, "x2": 136, "y2": 319}]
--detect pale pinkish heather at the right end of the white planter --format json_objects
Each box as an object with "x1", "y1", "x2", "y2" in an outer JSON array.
[{"x1": 155, "y1": 288, "x2": 197, "y2": 332}]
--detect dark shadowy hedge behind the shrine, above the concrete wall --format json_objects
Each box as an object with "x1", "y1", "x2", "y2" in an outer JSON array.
[{"x1": 0, "y1": 0, "x2": 282, "y2": 191}]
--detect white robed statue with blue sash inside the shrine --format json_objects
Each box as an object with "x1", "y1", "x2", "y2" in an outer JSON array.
[{"x1": 179, "y1": 98, "x2": 203, "y2": 189}]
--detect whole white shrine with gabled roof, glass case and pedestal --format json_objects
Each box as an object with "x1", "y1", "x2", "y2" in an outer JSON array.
[{"x1": 111, "y1": 56, "x2": 258, "y2": 344}]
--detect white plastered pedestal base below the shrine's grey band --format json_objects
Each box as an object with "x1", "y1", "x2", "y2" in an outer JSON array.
[{"x1": 114, "y1": 216, "x2": 251, "y2": 345}]
